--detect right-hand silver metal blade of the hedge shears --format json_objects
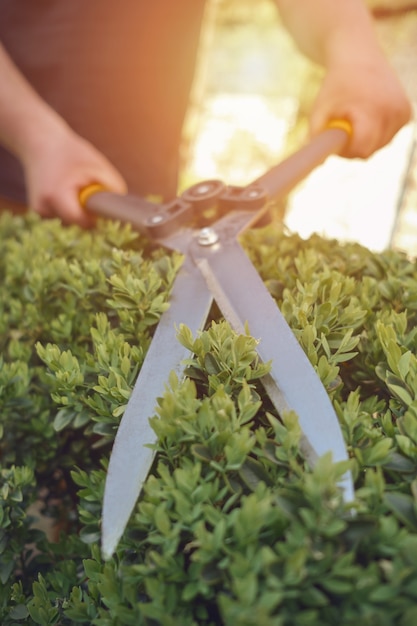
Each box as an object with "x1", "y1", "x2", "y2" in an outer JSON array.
[{"x1": 192, "y1": 216, "x2": 353, "y2": 492}]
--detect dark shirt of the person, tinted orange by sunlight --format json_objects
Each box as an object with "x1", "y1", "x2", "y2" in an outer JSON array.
[{"x1": 0, "y1": 0, "x2": 204, "y2": 202}]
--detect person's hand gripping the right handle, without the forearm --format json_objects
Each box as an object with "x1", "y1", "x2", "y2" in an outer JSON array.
[{"x1": 310, "y1": 57, "x2": 412, "y2": 158}]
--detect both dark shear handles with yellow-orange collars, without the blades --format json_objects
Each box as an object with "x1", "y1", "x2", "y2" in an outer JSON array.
[{"x1": 80, "y1": 120, "x2": 352, "y2": 239}]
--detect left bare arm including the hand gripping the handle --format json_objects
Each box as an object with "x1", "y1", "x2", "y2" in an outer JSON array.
[{"x1": 0, "y1": 44, "x2": 126, "y2": 226}]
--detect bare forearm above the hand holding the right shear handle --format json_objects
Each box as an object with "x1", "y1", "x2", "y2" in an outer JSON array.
[{"x1": 276, "y1": 0, "x2": 382, "y2": 69}]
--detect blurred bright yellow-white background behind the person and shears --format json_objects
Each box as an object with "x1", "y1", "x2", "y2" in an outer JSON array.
[{"x1": 181, "y1": 0, "x2": 417, "y2": 257}]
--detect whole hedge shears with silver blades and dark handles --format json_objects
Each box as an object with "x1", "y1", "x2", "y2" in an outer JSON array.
[{"x1": 80, "y1": 120, "x2": 354, "y2": 559}]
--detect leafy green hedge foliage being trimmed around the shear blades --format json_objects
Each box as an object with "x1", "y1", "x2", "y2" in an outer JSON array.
[{"x1": 0, "y1": 213, "x2": 417, "y2": 626}]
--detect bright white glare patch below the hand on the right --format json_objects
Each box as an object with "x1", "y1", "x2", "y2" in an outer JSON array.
[{"x1": 285, "y1": 124, "x2": 415, "y2": 252}]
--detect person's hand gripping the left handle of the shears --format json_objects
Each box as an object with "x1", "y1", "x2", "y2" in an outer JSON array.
[{"x1": 22, "y1": 126, "x2": 126, "y2": 227}]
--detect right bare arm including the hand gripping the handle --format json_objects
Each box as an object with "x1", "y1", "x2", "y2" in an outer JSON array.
[{"x1": 276, "y1": 0, "x2": 411, "y2": 158}]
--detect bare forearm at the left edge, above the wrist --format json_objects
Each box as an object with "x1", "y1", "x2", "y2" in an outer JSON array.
[{"x1": 0, "y1": 44, "x2": 66, "y2": 161}]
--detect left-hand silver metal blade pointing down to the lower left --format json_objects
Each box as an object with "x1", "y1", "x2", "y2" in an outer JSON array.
[{"x1": 102, "y1": 258, "x2": 213, "y2": 558}]
